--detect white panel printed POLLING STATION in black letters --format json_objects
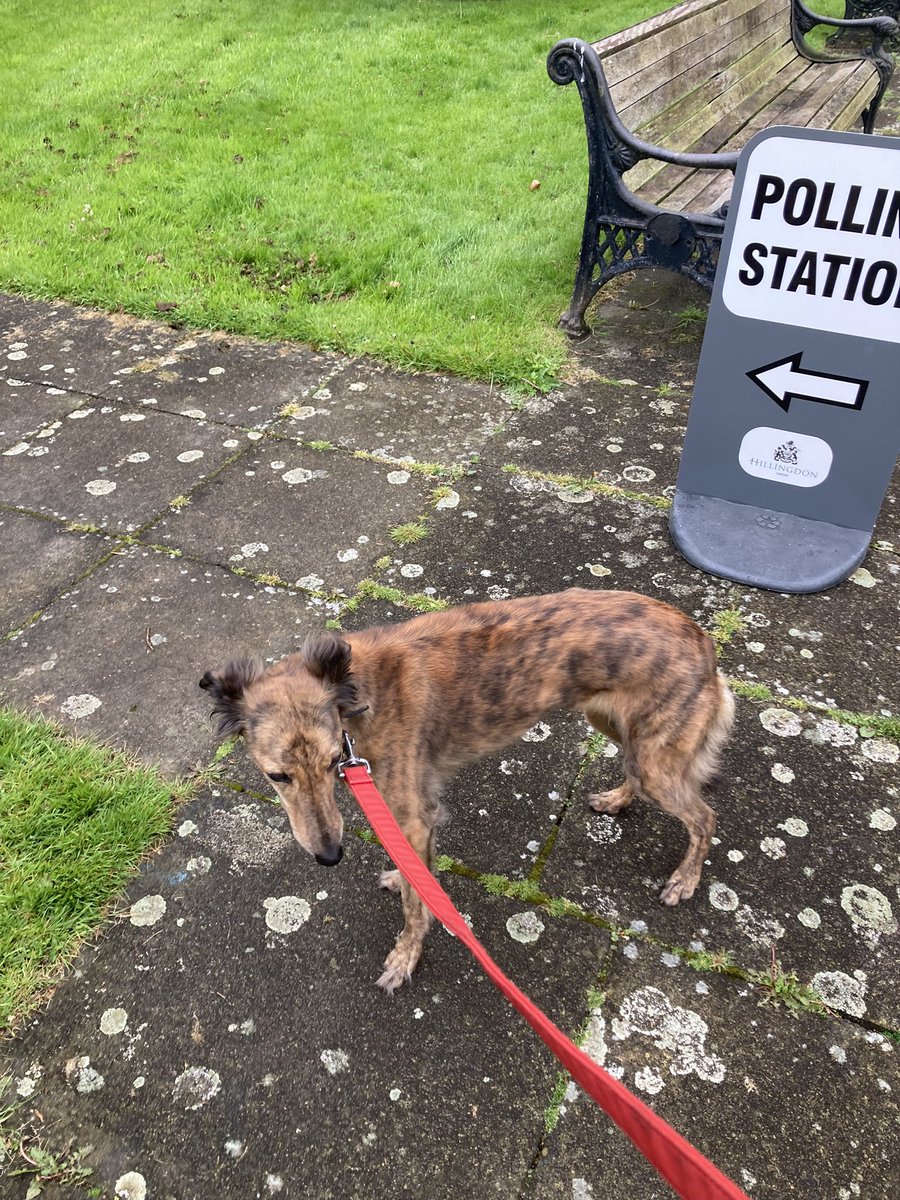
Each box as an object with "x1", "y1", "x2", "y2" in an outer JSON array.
[{"x1": 722, "y1": 137, "x2": 900, "y2": 343}]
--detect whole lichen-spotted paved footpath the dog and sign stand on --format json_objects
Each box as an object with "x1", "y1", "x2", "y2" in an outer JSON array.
[{"x1": 0, "y1": 272, "x2": 900, "y2": 1200}]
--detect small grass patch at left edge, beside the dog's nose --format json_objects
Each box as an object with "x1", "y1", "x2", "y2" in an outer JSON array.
[{"x1": 0, "y1": 708, "x2": 187, "y2": 1030}]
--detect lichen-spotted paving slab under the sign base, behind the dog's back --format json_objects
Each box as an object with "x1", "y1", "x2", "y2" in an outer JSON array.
[{"x1": 386, "y1": 467, "x2": 900, "y2": 712}]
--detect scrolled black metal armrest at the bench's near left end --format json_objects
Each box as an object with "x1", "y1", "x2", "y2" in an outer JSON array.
[{"x1": 547, "y1": 37, "x2": 738, "y2": 172}]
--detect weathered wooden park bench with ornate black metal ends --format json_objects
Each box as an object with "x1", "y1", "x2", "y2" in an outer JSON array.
[{"x1": 547, "y1": 0, "x2": 898, "y2": 336}]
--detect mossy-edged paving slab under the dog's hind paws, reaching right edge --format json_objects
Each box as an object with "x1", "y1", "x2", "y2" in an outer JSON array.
[{"x1": 541, "y1": 702, "x2": 900, "y2": 1026}]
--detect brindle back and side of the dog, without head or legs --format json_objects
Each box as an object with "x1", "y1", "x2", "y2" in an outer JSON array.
[{"x1": 347, "y1": 588, "x2": 720, "y2": 764}]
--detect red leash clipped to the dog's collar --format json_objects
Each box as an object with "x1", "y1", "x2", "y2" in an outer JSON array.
[{"x1": 340, "y1": 763, "x2": 748, "y2": 1200}]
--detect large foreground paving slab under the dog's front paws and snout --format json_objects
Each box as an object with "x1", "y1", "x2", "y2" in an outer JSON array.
[{"x1": 3, "y1": 794, "x2": 607, "y2": 1200}]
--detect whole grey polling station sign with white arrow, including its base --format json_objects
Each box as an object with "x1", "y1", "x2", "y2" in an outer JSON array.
[{"x1": 670, "y1": 127, "x2": 900, "y2": 592}]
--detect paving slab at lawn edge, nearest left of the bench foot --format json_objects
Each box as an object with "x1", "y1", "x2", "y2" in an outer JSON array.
[{"x1": 278, "y1": 359, "x2": 509, "y2": 463}]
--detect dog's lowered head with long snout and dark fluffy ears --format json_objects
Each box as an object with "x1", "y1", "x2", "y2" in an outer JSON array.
[{"x1": 200, "y1": 634, "x2": 359, "y2": 866}]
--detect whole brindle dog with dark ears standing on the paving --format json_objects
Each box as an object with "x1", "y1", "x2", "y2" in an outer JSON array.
[{"x1": 200, "y1": 588, "x2": 734, "y2": 992}]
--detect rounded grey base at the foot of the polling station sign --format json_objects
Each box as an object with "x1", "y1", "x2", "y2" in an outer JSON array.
[{"x1": 668, "y1": 490, "x2": 871, "y2": 593}]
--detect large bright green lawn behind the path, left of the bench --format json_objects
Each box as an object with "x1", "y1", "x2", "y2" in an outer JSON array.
[{"x1": 0, "y1": 0, "x2": 664, "y2": 388}]
